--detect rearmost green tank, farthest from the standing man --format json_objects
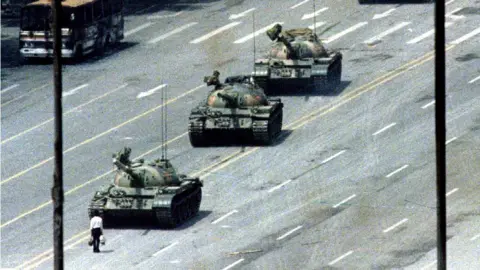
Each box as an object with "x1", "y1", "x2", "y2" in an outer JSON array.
[{"x1": 253, "y1": 24, "x2": 342, "y2": 93}]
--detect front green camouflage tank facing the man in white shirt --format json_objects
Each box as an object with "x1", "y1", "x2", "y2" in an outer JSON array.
[{"x1": 88, "y1": 147, "x2": 203, "y2": 228}]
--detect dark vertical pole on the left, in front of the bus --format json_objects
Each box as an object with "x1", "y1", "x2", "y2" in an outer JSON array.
[{"x1": 51, "y1": 0, "x2": 64, "y2": 270}]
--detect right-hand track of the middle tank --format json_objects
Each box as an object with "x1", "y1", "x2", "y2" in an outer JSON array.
[{"x1": 252, "y1": 110, "x2": 283, "y2": 145}]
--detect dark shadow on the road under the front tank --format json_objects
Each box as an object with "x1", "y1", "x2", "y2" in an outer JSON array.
[{"x1": 103, "y1": 210, "x2": 212, "y2": 229}]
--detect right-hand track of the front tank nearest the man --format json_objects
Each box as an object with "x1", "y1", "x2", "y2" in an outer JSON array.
[{"x1": 155, "y1": 187, "x2": 202, "y2": 228}]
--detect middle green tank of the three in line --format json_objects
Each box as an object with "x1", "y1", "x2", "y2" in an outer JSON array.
[{"x1": 188, "y1": 71, "x2": 283, "y2": 147}]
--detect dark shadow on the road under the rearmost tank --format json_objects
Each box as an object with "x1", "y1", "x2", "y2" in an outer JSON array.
[{"x1": 268, "y1": 81, "x2": 351, "y2": 97}]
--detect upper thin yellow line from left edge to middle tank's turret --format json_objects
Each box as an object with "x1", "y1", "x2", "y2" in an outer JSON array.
[{"x1": 0, "y1": 85, "x2": 204, "y2": 185}]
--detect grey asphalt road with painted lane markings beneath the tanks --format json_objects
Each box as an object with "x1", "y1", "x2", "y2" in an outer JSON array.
[{"x1": 0, "y1": 0, "x2": 480, "y2": 269}]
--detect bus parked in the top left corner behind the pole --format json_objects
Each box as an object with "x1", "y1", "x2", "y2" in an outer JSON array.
[{"x1": 19, "y1": 0, "x2": 124, "y2": 60}]
